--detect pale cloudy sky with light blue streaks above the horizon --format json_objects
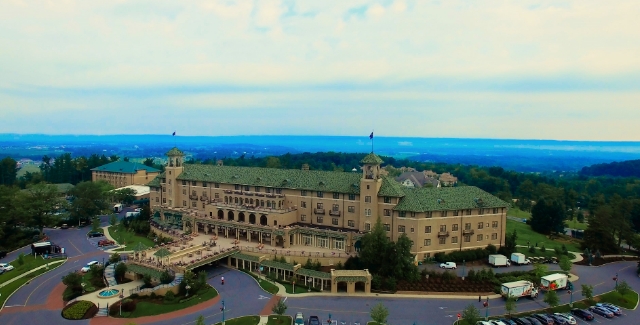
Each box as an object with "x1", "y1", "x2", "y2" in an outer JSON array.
[{"x1": 0, "y1": 0, "x2": 640, "y2": 141}]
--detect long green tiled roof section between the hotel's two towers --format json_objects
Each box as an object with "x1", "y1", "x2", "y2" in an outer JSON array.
[{"x1": 175, "y1": 164, "x2": 361, "y2": 194}]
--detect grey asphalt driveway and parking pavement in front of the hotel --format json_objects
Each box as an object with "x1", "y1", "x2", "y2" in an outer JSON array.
[{"x1": 0, "y1": 224, "x2": 640, "y2": 325}]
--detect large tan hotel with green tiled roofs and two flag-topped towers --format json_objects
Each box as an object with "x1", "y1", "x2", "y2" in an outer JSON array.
[{"x1": 148, "y1": 148, "x2": 508, "y2": 258}]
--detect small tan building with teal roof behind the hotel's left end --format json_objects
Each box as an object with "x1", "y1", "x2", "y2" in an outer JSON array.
[{"x1": 91, "y1": 161, "x2": 160, "y2": 188}]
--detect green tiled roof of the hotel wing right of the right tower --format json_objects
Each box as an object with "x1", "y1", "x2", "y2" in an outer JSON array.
[{"x1": 393, "y1": 186, "x2": 509, "y2": 212}]
